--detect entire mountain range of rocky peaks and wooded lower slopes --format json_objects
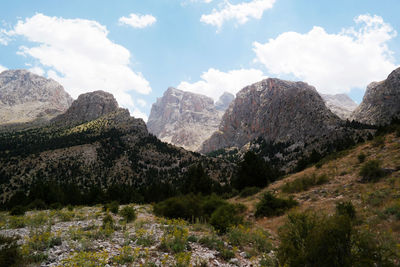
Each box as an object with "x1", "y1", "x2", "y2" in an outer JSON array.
[{"x1": 0, "y1": 69, "x2": 400, "y2": 205}]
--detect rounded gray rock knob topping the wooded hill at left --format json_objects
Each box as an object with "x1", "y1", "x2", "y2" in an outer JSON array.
[{"x1": 53, "y1": 91, "x2": 118, "y2": 124}]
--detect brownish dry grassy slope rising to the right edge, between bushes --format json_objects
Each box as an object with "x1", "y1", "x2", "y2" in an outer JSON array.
[{"x1": 231, "y1": 134, "x2": 400, "y2": 243}]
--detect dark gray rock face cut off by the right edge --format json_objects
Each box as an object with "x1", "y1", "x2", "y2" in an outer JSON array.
[{"x1": 350, "y1": 68, "x2": 400, "y2": 125}]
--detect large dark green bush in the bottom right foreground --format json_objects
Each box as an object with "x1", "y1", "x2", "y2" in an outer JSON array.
[{"x1": 277, "y1": 213, "x2": 396, "y2": 267}]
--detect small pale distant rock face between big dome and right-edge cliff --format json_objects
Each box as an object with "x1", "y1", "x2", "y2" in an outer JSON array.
[{"x1": 321, "y1": 94, "x2": 358, "y2": 120}]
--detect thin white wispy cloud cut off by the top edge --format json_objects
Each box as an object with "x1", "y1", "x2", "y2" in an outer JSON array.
[{"x1": 200, "y1": 0, "x2": 275, "y2": 29}]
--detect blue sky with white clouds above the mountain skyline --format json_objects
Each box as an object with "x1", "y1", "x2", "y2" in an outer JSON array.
[{"x1": 0, "y1": 0, "x2": 400, "y2": 120}]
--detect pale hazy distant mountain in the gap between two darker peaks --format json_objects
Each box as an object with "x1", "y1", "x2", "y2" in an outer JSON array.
[{"x1": 147, "y1": 87, "x2": 234, "y2": 151}]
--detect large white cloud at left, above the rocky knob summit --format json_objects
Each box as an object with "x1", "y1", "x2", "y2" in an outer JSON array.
[{"x1": 8, "y1": 14, "x2": 151, "y2": 120}]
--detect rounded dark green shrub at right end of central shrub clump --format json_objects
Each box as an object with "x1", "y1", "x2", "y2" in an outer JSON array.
[{"x1": 210, "y1": 204, "x2": 243, "y2": 234}]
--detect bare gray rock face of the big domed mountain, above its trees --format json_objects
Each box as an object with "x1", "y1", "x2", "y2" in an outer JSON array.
[{"x1": 201, "y1": 79, "x2": 341, "y2": 153}]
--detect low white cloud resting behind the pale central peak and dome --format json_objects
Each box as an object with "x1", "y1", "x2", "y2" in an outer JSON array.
[{"x1": 178, "y1": 68, "x2": 267, "y2": 100}]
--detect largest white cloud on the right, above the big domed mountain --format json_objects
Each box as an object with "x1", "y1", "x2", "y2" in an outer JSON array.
[{"x1": 254, "y1": 15, "x2": 396, "y2": 93}]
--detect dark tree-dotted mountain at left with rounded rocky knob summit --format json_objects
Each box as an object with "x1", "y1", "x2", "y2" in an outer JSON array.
[{"x1": 0, "y1": 91, "x2": 233, "y2": 202}]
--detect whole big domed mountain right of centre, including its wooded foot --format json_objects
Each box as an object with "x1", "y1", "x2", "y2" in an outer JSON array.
[{"x1": 201, "y1": 79, "x2": 366, "y2": 168}]
